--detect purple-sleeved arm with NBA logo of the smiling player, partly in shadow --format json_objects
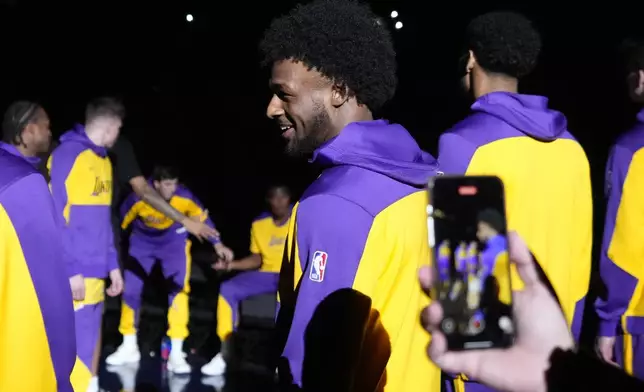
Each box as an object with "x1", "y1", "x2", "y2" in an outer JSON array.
[{"x1": 293, "y1": 195, "x2": 372, "y2": 391}]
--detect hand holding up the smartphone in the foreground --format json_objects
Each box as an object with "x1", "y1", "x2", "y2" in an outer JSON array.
[{"x1": 419, "y1": 233, "x2": 573, "y2": 392}]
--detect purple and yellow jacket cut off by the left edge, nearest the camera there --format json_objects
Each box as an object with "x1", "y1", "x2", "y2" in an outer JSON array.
[{"x1": 0, "y1": 143, "x2": 76, "y2": 392}]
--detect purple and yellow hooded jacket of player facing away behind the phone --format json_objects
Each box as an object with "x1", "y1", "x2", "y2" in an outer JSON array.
[{"x1": 438, "y1": 92, "x2": 593, "y2": 338}]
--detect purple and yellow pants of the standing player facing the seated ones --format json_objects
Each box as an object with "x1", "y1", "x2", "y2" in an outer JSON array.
[{"x1": 70, "y1": 278, "x2": 105, "y2": 391}]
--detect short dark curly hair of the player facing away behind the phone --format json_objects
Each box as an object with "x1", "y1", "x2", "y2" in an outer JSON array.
[{"x1": 466, "y1": 11, "x2": 541, "y2": 78}]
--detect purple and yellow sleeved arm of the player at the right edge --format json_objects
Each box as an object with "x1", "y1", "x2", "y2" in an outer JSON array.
[{"x1": 595, "y1": 145, "x2": 644, "y2": 337}]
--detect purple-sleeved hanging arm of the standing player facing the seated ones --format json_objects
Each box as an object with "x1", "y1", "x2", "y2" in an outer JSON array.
[{"x1": 47, "y1": 148, "x2": 82, "y2": 278}]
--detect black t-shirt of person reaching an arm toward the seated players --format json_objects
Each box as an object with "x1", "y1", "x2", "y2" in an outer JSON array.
[{"x1": 108, "y1": 136, "x2": 143, "y2": 227}]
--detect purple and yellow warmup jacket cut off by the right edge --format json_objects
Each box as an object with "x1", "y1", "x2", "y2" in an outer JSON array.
[{"x1": 595, "y1": 110, "x2": 644, "y2": 336}]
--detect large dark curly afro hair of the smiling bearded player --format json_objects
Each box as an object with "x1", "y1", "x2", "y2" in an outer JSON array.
[{"x1": 260, "y1": 0, "x2": 398, "y2": 111}]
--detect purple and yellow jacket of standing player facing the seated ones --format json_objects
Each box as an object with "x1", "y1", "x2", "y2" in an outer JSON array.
[{"x1": 47, "y1": 125, "x2": 118, "y2": 278}]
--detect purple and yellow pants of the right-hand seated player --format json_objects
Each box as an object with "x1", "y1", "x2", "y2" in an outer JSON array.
[{"x1": 217, "y1": 271, "x2": 279, "y2": 342}]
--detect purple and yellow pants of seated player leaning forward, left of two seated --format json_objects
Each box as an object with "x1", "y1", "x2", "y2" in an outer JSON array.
[{"x1": 119, "y1": 240, "x2": 192, "y2": 339}]
